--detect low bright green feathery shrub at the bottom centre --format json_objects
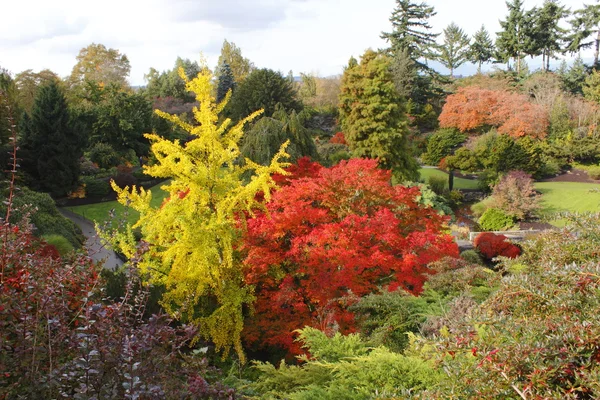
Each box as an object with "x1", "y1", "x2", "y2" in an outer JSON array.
[{"x1": 250, "y1": 327, "x2": 441, "y2": 400}]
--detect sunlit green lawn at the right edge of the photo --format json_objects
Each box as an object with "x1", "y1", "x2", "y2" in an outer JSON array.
[{"x1": 535, "y1": 182, "x2": 600, "y2": 226}]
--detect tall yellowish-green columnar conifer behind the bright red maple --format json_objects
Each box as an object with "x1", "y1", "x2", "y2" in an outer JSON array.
[{"x1": 340, "y1": 50, "x2": 418, "y2": 181}]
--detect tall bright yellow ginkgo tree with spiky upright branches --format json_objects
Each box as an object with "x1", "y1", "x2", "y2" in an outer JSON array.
[{"x1": 112, "y1": 68, "x2": 287, "y2": 358}]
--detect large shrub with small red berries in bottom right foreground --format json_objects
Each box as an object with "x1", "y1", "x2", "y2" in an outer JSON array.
[{"x1": 414, "y1": 220, "x2": 600, "y2": 400}]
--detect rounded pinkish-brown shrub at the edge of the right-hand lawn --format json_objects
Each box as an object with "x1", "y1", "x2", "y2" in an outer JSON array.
[{"x1": 490, "y1": 171, "x2": 539, "y2": 220}]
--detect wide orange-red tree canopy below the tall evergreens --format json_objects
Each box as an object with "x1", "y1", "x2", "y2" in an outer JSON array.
[{"x1": 439, "y1": 86, "x2": 549, "y2": 138}]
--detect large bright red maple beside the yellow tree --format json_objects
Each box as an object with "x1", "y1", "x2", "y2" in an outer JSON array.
[{"x1": 244, "y1": 159, "x2": 458, "y2": 353}]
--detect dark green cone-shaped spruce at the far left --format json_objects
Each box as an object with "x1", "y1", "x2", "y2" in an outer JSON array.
[{"x1": 20, "y1": 82, "x2": 82, "y2": 196}]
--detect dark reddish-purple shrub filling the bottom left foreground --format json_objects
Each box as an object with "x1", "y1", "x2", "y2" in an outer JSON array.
[{"x1": 0, "y1": 221, "x2": 235, "y2": 399}]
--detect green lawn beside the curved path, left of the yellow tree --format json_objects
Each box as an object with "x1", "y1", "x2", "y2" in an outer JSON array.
[{"x1": 65, "y1": 182, "x2": 168, "y2": 225}]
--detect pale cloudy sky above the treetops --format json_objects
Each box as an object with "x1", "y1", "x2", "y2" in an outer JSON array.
[{"x1": 0, "y1": 0, "x2": 592, "y2": 86}]
